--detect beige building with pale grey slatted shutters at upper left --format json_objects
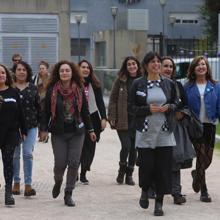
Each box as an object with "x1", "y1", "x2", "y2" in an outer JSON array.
[{"x1": 0, "y1": 0, "x2": 70, "y2": 74}]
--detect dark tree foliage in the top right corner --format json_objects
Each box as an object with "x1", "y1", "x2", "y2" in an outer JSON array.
[{"x1": 200, "y1": 0, "x2": 220, "y2": 43}]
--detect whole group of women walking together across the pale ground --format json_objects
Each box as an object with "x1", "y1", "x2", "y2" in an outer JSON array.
[{"x1": 0, "y1": 52, "x2": 220, "y2": 216}]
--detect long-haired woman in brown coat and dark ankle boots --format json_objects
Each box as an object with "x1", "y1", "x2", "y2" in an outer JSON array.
[{"x1": 108, "y1": 56, "x2": 141, "y2": 185}]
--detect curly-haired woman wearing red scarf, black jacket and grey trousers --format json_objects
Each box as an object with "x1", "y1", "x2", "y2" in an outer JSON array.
[{"x1": 40, "y1": 60, "x2": 96, "y2": 206}]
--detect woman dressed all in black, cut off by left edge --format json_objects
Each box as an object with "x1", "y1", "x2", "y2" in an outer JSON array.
[{"x1": 0, "y1": 64, "x2": 27, "y2": 205}]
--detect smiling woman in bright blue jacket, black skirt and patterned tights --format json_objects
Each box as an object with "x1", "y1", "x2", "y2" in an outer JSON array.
[{"x1": 184, "y1": 56, "x2": 220, "y2": 202}]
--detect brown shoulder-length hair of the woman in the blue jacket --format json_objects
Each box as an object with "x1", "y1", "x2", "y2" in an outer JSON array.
[{"x1": 187, "y1": 56, "x2": 216, "y2": 83}]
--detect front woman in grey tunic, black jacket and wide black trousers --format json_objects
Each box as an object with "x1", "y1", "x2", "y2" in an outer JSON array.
[{"x1": 129, "y1": 52, "x2": 177, "y2": 216}]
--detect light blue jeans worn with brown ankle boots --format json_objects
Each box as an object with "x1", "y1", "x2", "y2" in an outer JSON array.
[{"x1": 13, "y1": 127, "x2": 37, "y2": 185}]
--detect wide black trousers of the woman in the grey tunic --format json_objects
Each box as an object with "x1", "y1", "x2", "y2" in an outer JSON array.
[{"x1": 138, "y1": 146, "x2": 173, "y2": 196}]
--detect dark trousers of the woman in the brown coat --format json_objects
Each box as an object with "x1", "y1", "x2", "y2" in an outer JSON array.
[{"x1": 117, "y1": 130, "x2": 137, "y2": 167}]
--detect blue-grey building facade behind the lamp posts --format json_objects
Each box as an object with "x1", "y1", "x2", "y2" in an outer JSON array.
[{"x1": 70, "y1": 0, "x2": 203, "y2": 68}]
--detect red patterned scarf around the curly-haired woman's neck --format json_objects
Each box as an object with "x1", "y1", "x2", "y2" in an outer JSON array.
[{"x1": 51, "y1": 81, "x2": 82, "y2": 119}]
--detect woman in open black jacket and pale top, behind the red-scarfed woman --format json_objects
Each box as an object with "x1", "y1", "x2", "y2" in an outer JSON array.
[{"x1": 79, "y1": 60, "x2": 106, "y2": 184}]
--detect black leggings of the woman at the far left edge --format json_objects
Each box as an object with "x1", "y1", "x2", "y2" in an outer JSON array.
[{"x1": 1, "y1": 145, "x2": 15, "y2": 191}]
